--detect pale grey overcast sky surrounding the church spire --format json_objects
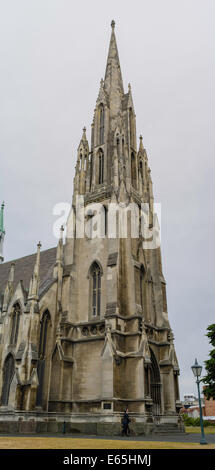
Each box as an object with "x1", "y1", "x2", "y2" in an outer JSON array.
[{"x1": 0, "y1": 0, "x2": 215, "y2": 397}]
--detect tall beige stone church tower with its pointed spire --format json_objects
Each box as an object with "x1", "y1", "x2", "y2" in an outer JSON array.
[{"x1": 57, "y1": 21, "x2": 180, "y2": 432}]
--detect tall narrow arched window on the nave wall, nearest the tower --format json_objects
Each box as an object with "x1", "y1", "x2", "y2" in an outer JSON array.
[{"x1": 36, "y1": 310, "x2": 51, "y2": 406}]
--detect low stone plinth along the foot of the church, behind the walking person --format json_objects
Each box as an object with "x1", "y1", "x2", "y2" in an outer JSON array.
[{"x1": 0, "y1": 410, "x2": 184, "y2": 436}]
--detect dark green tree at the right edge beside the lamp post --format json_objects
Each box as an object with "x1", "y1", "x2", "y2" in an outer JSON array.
[{"x1": 202, "y1": 323, "x2": 215, "y2": 399}]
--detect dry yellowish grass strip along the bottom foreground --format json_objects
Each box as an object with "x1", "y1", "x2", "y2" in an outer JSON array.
[{"x1": 0, "y1": 436, "x2": 215, "y2": 450}]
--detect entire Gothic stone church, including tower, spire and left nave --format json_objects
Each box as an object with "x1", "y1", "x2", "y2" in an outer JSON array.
[{"x1": 0, "y1": 21, "x2": 181, "y2": 435}]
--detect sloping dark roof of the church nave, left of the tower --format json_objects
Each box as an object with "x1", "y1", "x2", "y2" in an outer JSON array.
[{"x1": 0, "y1": 247, "x2": 57, "y2": 294}]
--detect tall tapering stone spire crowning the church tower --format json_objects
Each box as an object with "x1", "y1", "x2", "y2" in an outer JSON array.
[{"x1": 104, "y1": 20, "x2": 124, "y2": 95}]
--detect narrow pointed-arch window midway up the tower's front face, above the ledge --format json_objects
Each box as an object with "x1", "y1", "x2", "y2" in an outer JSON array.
[{"x1": 90, "y1": 261, "x2": 102, "y2": 317}]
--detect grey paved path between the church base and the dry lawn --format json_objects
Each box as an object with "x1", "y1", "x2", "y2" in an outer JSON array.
[{"x1": 0, "y1": 433, "x2": 215, "y2": 444}]
